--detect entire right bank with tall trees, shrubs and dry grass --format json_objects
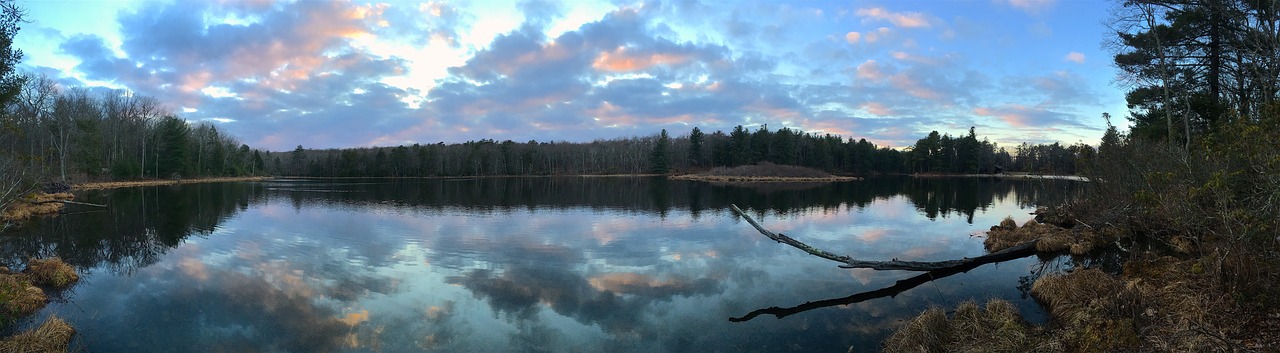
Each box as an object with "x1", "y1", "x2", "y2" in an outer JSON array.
[{"x1": 884, "y1": 0, "x2": 1280, "y2": 352}]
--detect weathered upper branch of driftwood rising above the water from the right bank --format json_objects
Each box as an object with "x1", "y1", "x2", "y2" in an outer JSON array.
[{"x1": 730, "y1": 205, "x2": 1039, "y2": 271}]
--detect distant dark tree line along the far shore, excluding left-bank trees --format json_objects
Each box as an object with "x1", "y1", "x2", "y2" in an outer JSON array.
[{"x1": 266, "y1": 125, "x2": 1096, "y2": 177}]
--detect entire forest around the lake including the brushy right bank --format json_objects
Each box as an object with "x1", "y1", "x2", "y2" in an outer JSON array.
[{"x1": 0, "y1": 0, "x2": 1280, "y2": 352}]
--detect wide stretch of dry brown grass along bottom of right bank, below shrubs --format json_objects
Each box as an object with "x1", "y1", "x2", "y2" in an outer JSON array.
[{"x1": 884, "y1": 255, "x2": 1280, "y2": 352}]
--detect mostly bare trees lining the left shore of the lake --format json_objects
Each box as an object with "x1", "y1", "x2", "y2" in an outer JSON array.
[{"x1": 0, "y1": 73, "x2": 265, "y2": 180}]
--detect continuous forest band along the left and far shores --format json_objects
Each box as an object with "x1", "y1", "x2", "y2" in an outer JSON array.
[{"x1": 0, "y1": 78, "x2": 1096, "y2": 182}]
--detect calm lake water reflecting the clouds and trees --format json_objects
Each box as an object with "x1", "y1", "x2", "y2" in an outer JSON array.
[{"x1": 0, "y1": 178, "x2": 1075, "y2": 352}]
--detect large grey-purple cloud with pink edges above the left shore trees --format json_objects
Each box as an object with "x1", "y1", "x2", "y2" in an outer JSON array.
[{"x1": 52, "y1": 1, "x2": 432, "y2": 150}]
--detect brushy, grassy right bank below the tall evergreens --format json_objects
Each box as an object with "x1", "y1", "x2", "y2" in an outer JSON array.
[{"x1": 884, "y1": 112, "x2": 1280, "y2": 352}]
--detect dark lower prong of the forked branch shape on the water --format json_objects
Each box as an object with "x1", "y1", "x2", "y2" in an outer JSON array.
[{"x1": 728, "y1": 241, "x2": 1036, "y2": 322}]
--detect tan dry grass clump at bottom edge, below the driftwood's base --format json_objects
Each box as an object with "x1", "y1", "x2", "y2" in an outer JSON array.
[{"x1": 884, "y1": 299, "x2": 1061, "y2": 352}]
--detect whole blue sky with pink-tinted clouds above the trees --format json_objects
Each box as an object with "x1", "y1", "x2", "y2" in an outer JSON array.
[{"x1": 14, "y1": 0, "x2": 1126, "y2": 151}]
